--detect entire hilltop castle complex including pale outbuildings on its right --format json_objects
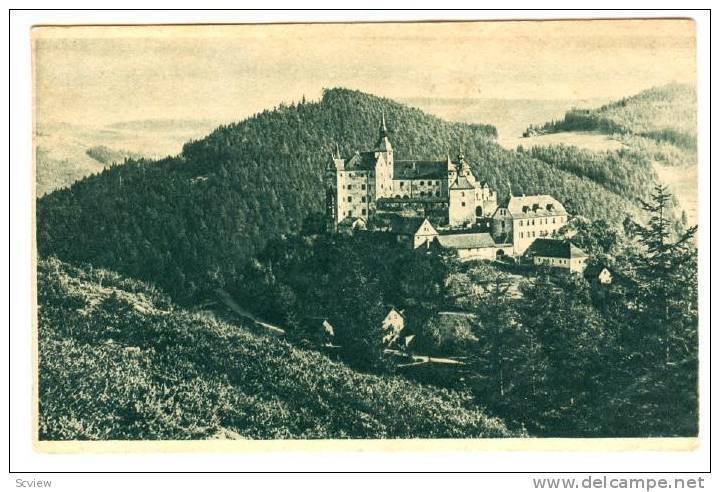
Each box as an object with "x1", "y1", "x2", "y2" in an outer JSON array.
[{"x1": 324, "y1": 115, "x2": 567, "y2": 264}]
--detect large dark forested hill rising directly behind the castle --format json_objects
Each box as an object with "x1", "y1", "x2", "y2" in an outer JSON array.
[{"x1": 37, "y1": 89, "x2": 639, "y2": 300}]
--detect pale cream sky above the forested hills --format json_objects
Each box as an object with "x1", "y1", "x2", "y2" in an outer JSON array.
[{"x1": 33, "y1": 20, "x2": 695, "y2": 127}]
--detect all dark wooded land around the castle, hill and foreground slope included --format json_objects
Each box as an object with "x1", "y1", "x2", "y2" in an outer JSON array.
[{"x1": 37, "y1": 89, "x2": 697, "y2": 439}]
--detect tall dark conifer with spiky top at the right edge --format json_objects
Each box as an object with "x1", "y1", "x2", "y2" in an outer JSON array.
[{"x1": 610, "y1": 186, "x2": 698, "y2": 435}]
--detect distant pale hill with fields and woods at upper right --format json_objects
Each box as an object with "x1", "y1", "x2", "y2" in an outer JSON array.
[{"x1": 518, "y1": 84, "x2": 698, "y2": 224}]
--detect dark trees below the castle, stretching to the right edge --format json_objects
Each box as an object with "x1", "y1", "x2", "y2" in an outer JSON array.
[{"x1": 227, "y1": 187, "x2": 697, "y2": 437}]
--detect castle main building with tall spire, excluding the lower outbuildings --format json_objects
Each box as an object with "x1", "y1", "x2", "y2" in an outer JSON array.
[{"x1": 325, "y1": 116, "x2": 497, "y2": 231}]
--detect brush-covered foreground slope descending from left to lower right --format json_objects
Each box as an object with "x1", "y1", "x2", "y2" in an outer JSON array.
[{"x1": 38, "y1": 259, "x2": 520, "y2": 440}]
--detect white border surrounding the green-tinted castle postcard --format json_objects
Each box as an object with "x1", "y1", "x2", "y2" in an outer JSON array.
[{"x1": 2, "y1": 6, "x2": 717, "y2": 472}]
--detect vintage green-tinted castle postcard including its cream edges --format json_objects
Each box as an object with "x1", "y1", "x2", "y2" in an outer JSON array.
[{"x1": 32, "y1": 19, "x2": 700, "y2": 452}]
